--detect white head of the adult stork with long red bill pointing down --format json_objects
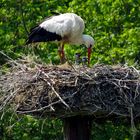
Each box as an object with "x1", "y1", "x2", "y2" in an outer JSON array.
[{"x1": 83, "y1": 35, "x2": 94, "y2": 64}]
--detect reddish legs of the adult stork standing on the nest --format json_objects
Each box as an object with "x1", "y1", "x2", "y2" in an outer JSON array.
[{"x1": 58, "y1": 43, "x2": 65, "y2": 64}]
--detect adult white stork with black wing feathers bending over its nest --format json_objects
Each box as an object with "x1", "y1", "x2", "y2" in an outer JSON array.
[{"x1": 26, "y1": 13, "x2": 94, "y2": 64}]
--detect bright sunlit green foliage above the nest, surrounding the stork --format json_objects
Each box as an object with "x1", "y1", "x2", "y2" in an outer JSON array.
[{"x1": 0, "y1": 0, "x2": 140, "y2": 64}]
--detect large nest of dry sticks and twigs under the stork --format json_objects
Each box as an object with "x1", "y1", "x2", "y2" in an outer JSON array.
[{"x1": 0, "y1": 59, "x2": 140, "y2": 117}]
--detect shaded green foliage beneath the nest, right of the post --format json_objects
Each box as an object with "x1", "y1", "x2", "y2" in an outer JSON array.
[{"x1": 92, "y1": 121, "x2": 132, "y2": 140}]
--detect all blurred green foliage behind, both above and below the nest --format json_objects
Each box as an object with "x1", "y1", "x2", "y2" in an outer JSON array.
[{"x1": 0, "y1": 0, "x2": 140, "y2": 140}]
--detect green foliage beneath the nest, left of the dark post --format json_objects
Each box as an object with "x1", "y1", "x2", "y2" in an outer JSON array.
[{"x1": 0, "y1": 111, "x2": 63, "y2": 140}]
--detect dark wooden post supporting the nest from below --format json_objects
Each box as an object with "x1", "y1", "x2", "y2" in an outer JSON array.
[{"x1": 63, "y1": 116, "x2": 92, "y2": 140}]
